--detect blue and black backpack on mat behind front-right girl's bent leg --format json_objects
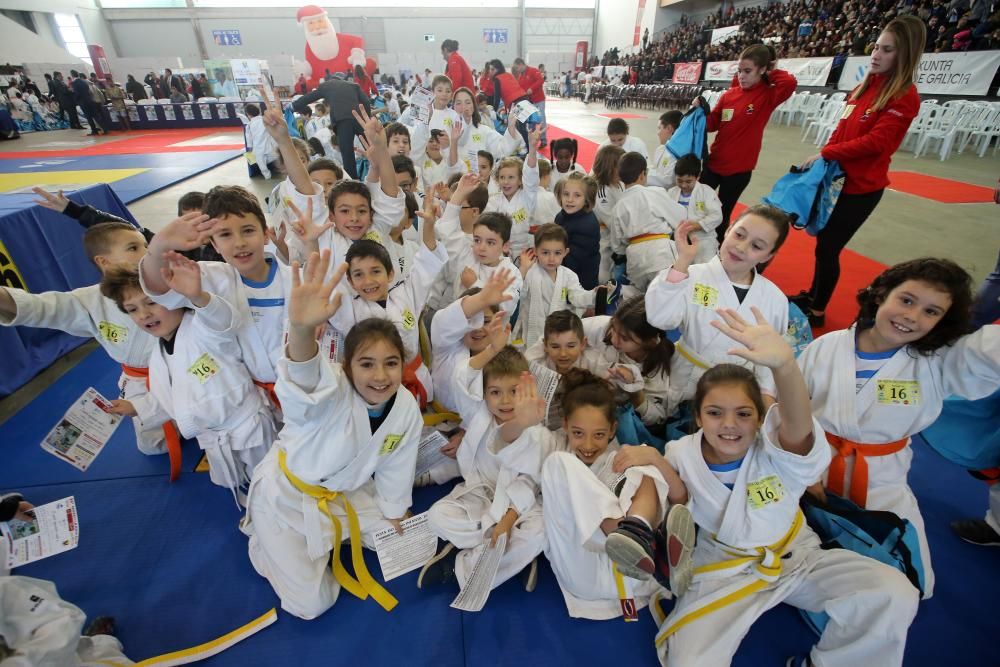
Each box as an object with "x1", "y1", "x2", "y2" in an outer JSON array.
[{"x1": 799, "y1": 491, "x2": 925, "y2": 635}]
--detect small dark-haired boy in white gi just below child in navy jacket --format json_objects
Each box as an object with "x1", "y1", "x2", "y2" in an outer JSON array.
[{"x1": 514, "y1": 223, "x2": 594, "y2": 347}]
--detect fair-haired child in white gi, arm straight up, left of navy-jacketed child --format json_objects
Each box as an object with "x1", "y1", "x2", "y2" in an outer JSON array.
[{"x1": 486, "y1": 125, "x2": 542, "y2": 257}]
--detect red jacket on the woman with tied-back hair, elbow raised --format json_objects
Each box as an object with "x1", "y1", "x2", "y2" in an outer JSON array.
[{"x1": 707, "y1": 69, "x2": 798, "y2": 176}]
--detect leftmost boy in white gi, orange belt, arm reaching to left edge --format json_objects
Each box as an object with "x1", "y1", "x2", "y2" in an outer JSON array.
[{"x1": 0, "y1": 222, "x2": 162, "y2": 455}]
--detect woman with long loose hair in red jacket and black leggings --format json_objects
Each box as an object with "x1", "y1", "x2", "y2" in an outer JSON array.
[{"x1": 790, "y1": 14, "x2": 927, "y2": 327}]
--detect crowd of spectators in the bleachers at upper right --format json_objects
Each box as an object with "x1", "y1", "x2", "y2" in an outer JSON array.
[{"x1": 600, "y1": 0, "x2": 1000, "y2": 83}]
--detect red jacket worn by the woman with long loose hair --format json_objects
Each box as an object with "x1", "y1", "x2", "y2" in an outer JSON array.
[{"x1": 821, "y1": 74, "x2": 920, "y2": 195}]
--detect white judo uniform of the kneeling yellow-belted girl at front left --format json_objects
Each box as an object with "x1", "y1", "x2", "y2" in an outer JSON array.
[{"x1": 243, "y1": 354, "x2": 423, "y2": 619}]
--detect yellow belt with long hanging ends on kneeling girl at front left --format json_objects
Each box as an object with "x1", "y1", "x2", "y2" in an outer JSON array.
[{"x1": 278, "y1": 450, "x2": 398, "y2": 611}]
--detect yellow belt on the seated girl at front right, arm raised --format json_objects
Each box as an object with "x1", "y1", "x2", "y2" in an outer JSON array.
[{"x1": 656, "y1": 511, "x2": 805, "y2": 646}]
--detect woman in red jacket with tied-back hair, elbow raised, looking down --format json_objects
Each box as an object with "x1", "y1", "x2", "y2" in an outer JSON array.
[{"x1": 692, "y1": 44, "x2": 798, "y2": 244}]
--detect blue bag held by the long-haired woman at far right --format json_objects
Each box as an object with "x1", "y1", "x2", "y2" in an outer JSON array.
[{"x1": 762, "y1": 158, "x2": 844, "y2": 236}]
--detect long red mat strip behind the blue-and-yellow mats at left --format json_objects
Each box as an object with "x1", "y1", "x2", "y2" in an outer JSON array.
[{"x1": 0, "y1": 127, "x2": 245, "y2": 159}]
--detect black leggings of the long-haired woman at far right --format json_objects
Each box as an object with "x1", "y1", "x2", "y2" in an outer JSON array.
[{"x1": 809, "y1": 190, "x2": 885, "y2": 312}]
